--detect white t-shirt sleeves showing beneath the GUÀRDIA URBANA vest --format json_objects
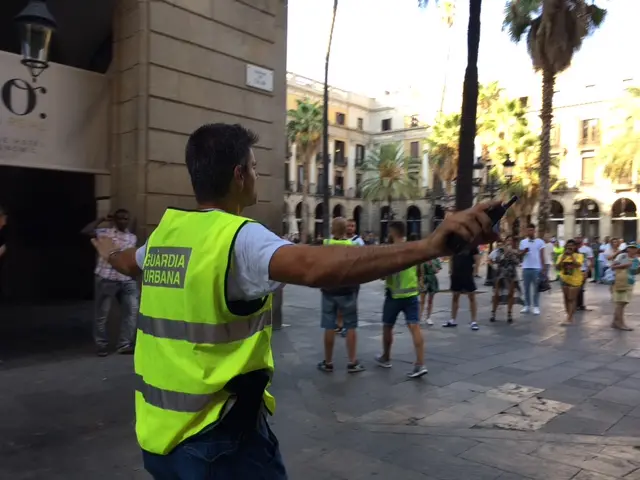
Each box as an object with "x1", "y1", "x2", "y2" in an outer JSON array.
[{"x1": 136, "y1": 222, "x2": 291, "y2": 301}]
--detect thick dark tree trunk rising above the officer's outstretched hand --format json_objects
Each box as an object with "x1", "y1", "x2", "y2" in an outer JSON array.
[{"x1": 456, "y1": 0, "x2": 482, "y2": 210}]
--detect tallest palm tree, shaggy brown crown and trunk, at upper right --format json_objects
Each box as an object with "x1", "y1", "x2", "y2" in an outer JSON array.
[{"x1": 504, "y1": 0, "x2": 607, "y2": 234}]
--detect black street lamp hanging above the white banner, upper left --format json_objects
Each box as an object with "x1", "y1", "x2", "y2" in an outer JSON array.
[{"x1": 15, "y1": 0, "x2": 58, "y2": 81}]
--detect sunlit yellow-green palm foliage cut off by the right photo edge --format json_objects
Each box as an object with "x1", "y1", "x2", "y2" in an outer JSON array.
[{"x1": 600, "y1": 88, "x2": 640, "y2": 185}]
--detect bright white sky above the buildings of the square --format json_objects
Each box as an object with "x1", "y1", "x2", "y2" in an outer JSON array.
[{"x1": 287, "y1": 0, "x2": 640, "y2": 97}]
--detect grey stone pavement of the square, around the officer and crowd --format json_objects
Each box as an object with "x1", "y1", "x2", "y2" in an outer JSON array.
[{"x1": 0, "y1": 279, "x2": 640, "y2": 480}]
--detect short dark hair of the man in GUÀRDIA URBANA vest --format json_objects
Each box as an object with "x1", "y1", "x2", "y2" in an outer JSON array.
[{"x1": 185, "y1": 123, "x2": 258, "y2": 203}]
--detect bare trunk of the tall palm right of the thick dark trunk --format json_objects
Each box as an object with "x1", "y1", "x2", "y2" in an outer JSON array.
[{"x1": 538, "y1": 69, "x2": 556, "y2": 237}]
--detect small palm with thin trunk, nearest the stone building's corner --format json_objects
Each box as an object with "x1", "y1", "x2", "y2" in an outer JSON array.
[{"x1": 287, "y1": 99, "x2": 328, "y2": 243}]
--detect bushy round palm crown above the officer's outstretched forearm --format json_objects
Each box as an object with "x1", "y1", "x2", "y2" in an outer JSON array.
[{"x1": 361, "y1": 143, "x2": 421, "y2": 215}]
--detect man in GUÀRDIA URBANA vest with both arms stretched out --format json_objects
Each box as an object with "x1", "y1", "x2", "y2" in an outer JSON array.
[{"x1": 92, "y1": 124, "x2": 498, "y2": 480}]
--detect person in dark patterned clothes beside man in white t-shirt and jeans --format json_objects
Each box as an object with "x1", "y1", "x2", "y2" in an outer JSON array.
[{"x1": 489, "y1": 235, "x2": 520, "y2": 323}]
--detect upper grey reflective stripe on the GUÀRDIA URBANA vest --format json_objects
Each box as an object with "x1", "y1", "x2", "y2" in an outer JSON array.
[{"x1": 138, "y1": 310, "x2": 272, "y2": 344}]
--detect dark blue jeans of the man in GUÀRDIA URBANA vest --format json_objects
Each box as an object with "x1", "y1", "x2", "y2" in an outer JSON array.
[{"x1": 142, "y1": 414, "x2": 287, "y2": 480}]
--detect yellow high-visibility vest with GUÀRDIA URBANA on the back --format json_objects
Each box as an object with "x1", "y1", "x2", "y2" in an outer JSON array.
[{"x1": 135, "y1": 209, "x2": 275, "y2": 455}]
